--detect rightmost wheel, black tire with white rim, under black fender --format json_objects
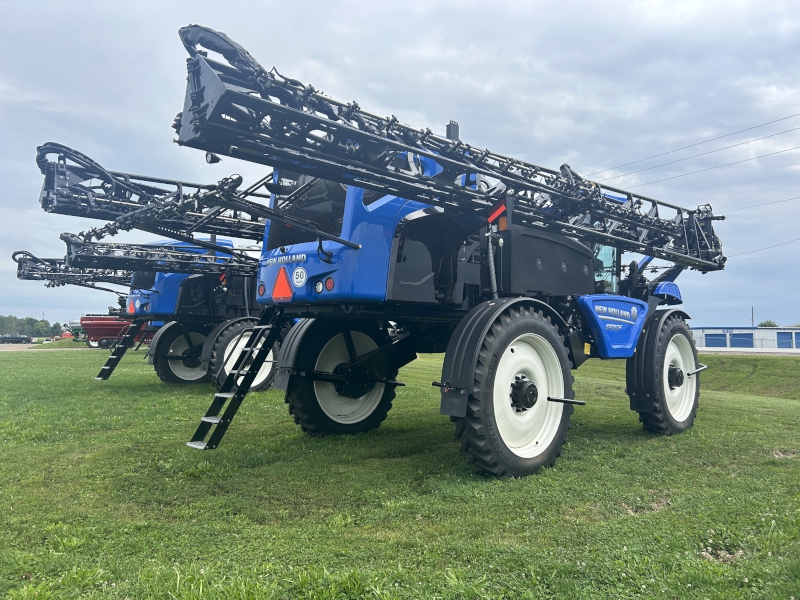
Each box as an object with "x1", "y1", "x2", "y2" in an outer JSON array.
[{"x1": 628, "y1": 315, "x2": 700, "y2": 435}]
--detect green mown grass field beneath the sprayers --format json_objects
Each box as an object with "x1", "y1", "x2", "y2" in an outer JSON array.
[{"x1": 0, "y1": 344, "x2": 800, "y2": 600}]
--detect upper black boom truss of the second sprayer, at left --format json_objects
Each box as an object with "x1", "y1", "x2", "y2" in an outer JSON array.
[{"x1": 36, "y1": 142, "x2": 359, "y2": 253}]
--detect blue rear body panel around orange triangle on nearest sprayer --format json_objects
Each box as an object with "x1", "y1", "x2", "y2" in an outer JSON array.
[{"x1": 257, "y1": 186, "x2": 428, "y2": 305}]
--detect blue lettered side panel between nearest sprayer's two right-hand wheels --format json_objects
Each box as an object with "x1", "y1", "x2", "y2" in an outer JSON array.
[{"x1": 578, "y1": 294, "x2": 647, "y2": 359}]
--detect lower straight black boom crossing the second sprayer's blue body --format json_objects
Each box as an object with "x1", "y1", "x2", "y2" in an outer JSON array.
[{"x1": 61, "y1": 233, "x2": 258, "y2": 281}]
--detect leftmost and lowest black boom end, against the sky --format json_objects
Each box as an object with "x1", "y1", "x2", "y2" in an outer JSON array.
[{"x1": 11, "y1": 250, "x2": 133, "y2": 294}]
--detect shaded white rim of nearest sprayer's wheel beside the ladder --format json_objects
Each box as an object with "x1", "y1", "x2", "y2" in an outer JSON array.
[{"x1": 314, "y1": 331, "x2": 385, "y2": 425}]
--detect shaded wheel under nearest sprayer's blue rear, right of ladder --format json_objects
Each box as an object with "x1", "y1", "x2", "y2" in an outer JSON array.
[{"x1": 286, "y1": 321, "x2": 397, "y2": 437}]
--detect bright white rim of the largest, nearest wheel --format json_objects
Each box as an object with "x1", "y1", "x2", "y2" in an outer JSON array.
[{"x1": 493, "y1": 333, "x2": 564, "y2": 458}]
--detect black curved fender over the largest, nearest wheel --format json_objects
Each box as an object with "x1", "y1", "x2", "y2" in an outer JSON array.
[{"x1": 439, "y1": 297, "x2": 583, "y2": 417}]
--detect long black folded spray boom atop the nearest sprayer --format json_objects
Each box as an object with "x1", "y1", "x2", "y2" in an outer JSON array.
[{"x1": 173, "y1": 25, "x2": 726, "y2": 271}]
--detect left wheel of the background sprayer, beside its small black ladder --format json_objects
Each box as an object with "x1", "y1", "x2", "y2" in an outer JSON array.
[{"x1": 153, "y1": 326, "x2": 208, "y2": 384}]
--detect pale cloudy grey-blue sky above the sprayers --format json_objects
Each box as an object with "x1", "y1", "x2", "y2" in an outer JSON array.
[{"x1": 0, "y1": 0, "x2": 800, "y2": 326}]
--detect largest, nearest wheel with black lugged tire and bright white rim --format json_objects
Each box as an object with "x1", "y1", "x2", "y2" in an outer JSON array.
[{"x1": 453, "y1": 307, "x2": 573, "y2": 477}]
